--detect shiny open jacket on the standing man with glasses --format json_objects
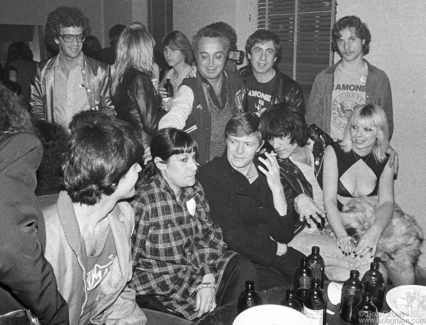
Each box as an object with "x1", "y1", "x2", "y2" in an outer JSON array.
[{"x1": 30, "y1": 53, "x2": 114, "y2": 122}]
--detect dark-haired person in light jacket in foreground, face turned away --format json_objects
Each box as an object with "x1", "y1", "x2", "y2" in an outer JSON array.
[{"x1": 43, "y1": 111, "x2": 146, "y2": 325}]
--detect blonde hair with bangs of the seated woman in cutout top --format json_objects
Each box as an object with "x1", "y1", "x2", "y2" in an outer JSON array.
[{"x1": 340, "y1": 104, "x2": 389, "y2": 162}]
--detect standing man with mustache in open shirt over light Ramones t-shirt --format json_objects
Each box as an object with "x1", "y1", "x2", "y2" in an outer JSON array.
[{"x1": 306, "y1": 16, "x2": 393, "y2": 140}]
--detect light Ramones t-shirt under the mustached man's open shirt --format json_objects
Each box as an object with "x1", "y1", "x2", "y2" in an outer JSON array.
[{"x1": 330, "y1": 64, "x2": 368, "y2": 140}]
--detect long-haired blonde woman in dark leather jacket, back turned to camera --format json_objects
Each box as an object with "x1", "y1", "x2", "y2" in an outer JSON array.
[{"x1": 111, "y1": 22, "x2": 161, "y2": 152}]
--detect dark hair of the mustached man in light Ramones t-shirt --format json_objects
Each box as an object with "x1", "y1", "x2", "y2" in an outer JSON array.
[{"x1": 331, "y1": 16, "x2": 371, "y2": 55}]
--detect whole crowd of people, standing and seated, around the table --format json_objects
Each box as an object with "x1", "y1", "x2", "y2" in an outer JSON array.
[{"x1": 0, "y1": 7, "x2": 423, "y2": 325}]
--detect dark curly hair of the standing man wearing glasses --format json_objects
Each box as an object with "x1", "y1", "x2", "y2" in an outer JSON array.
[{"x1": 44, "y1": 7, "x2": 90, "y2": 51}]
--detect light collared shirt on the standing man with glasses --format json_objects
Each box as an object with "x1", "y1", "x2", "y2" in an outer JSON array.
[{"x1": 53, "y1": 54, "x2": 90, "y2": 129}]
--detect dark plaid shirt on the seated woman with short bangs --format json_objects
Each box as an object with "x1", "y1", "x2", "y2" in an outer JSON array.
[{"x1": 131, "y1": 174, "x2": 236, "y2": 319}]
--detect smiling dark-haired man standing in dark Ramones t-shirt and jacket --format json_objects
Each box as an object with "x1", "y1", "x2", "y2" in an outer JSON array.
[{"x1": 238, "y1": 29, "x2": 305, "y2": 118}]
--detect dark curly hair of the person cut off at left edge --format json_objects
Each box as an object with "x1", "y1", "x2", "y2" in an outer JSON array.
[{"x1": 0, "y1": 82, "x2": 34, "y2": 136}]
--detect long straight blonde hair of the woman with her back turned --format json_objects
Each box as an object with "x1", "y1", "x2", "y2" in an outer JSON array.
[{"x1": 111, "y1": 22, "x2": 155, "y2": 94}]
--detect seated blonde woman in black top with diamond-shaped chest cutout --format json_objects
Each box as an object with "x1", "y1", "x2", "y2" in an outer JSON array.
[{"x1": 323, "y1": 104, "x2": 421, "y2": 285}]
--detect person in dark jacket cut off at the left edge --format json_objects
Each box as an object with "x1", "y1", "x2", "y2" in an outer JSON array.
[{"x1": 0, "y1": 82, "x2": 68, "y2": 324}]
